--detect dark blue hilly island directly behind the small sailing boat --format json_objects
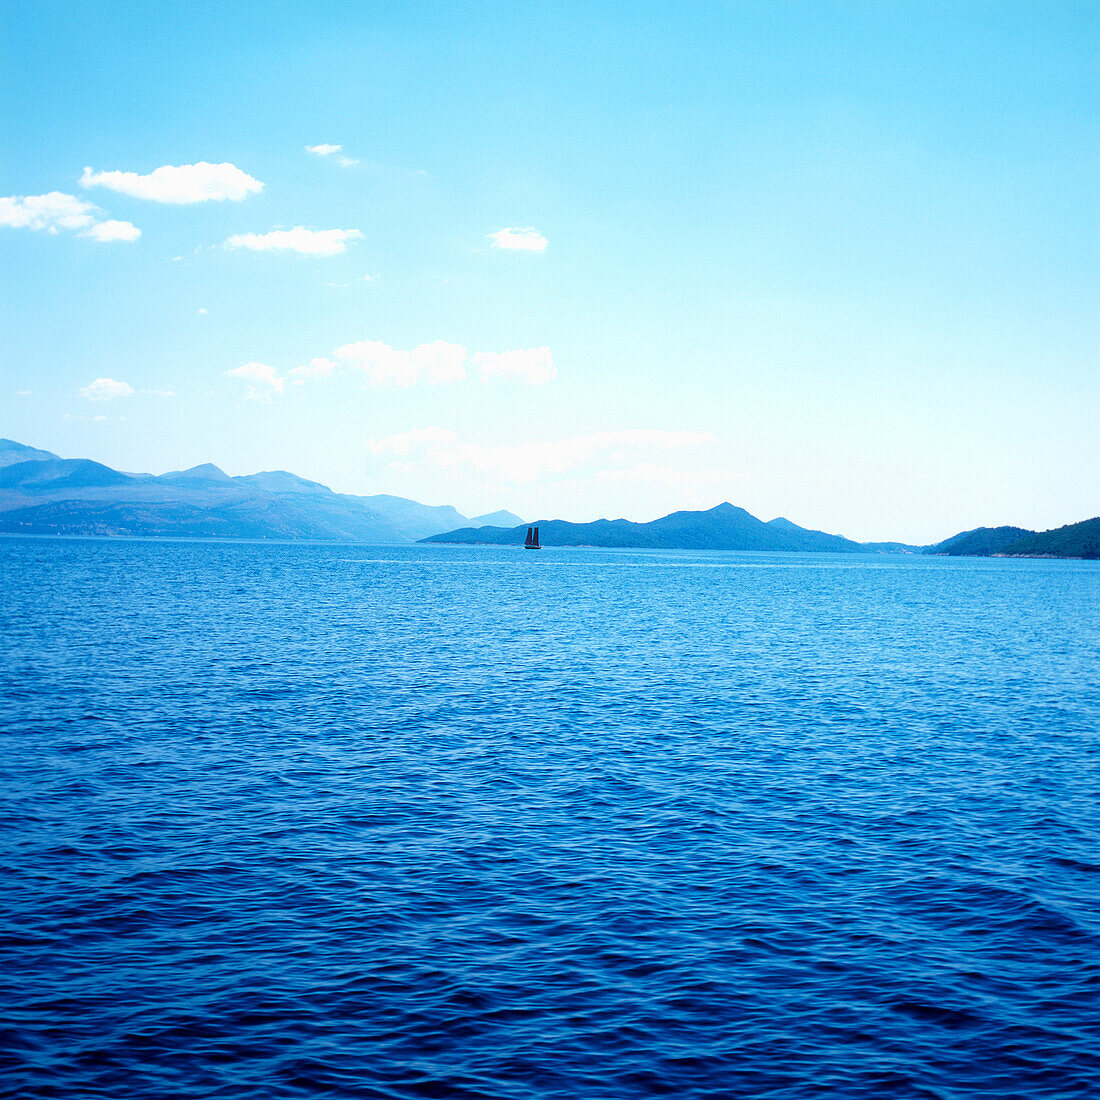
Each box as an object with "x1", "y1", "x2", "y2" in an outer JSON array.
[{"x1": 420, "y1": 504, "x2": 864, "y2": 553}]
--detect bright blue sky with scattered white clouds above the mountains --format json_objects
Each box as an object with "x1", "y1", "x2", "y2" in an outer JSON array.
[{"x1": 0, "y1": 0, "x2": 1100, "y2": 543}]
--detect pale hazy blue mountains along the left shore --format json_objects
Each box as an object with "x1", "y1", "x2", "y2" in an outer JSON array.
[{"x1": 0, "y1": 440, "x2": 512, "y2": 543}]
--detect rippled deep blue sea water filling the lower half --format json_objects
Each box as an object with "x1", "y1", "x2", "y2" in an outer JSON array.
[{"x1": 0, "y1": 538, "x2": 1100, "y2": 1100}]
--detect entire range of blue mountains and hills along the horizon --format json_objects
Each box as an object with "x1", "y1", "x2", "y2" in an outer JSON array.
[{"x1": 0, "y1": 439, "x2": 1100, "y2": 558}]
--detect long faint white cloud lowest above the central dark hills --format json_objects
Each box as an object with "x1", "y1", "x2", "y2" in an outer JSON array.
[{"x1": 369, "y1": 428, "x2": 715, "y2": 483}]
